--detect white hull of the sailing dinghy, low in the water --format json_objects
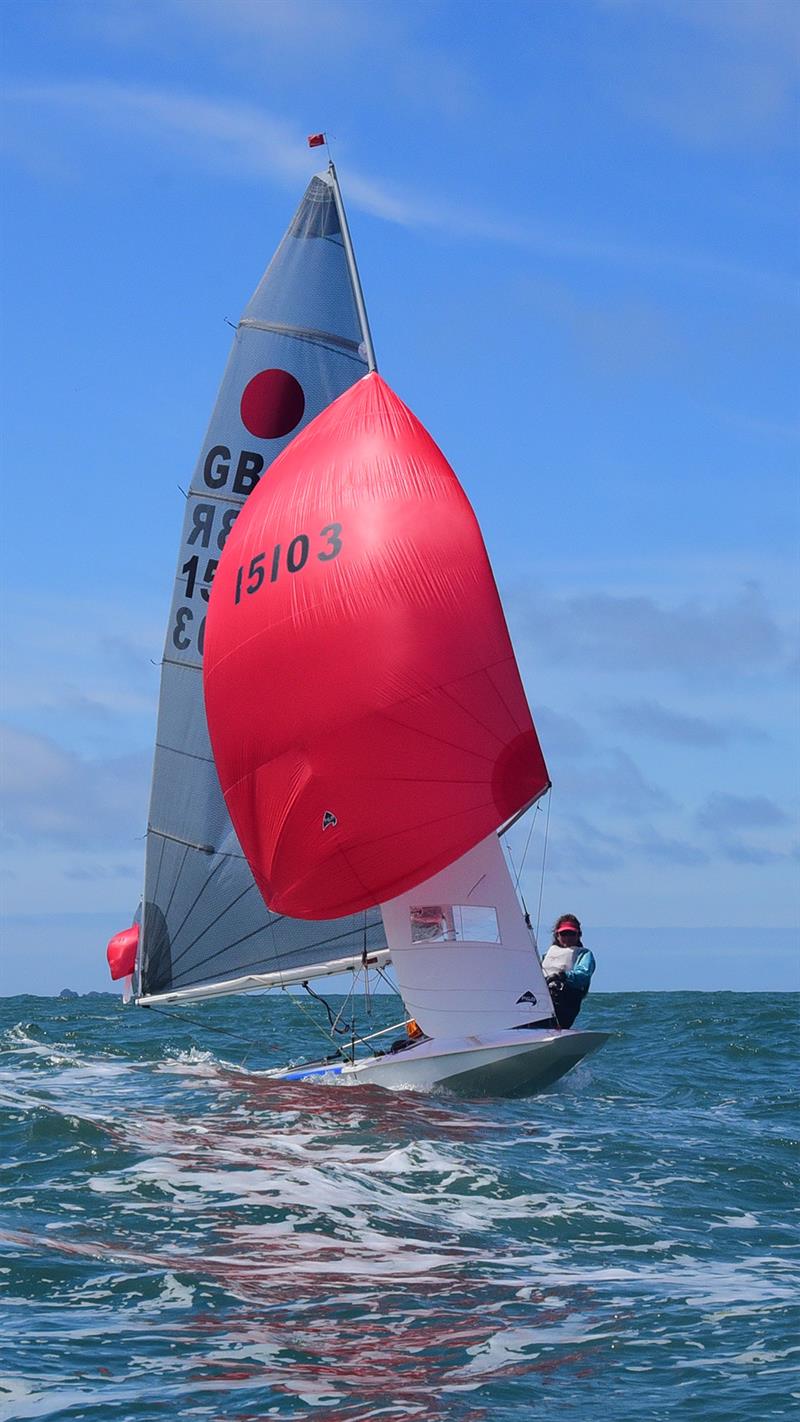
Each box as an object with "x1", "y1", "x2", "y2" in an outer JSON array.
[{"x1": 270, "y1": 1028, "x2": 608, "y2": 1096}]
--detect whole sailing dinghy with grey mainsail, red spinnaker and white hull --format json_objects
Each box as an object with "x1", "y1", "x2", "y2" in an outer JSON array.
[{"x1": 109, "y1": 155, "x2": 605, "y2": 1094}]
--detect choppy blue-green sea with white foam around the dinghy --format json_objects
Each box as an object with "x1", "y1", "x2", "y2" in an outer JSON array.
[{"x1": 0, "y1": 993, "x2": 800, "y2": 1422}]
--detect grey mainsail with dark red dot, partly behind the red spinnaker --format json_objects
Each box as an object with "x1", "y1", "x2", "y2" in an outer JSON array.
[{"x1": 138, "y1": 172, "x2": 385, "y2": 998}]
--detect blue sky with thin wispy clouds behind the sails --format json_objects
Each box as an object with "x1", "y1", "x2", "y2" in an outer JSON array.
[{"x1": 0, "y1": 0, "x2": 800, "y2": 993}]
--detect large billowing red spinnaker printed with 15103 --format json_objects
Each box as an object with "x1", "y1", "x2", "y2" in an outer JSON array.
[{"x1": 203, "y1": 373, "x2": 548, "y2": 921}]
